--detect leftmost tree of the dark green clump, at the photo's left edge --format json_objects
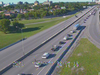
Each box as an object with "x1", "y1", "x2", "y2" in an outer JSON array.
[{"x1": 0, "y1": 19, "x2": 10, "y2": 34}]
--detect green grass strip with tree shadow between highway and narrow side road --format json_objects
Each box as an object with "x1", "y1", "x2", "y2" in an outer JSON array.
[{"x1": 0, "y1": 13, "x2": 78, "y2": 49}]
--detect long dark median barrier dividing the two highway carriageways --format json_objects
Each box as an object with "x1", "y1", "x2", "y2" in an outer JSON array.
[{"x1": 0, "y1": 7, "x2": 95, "y2": 75}]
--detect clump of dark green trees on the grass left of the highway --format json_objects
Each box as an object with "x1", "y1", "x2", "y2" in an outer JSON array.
[{"x1": 0, "y1": 19, "x2": 24, "y2": 34}]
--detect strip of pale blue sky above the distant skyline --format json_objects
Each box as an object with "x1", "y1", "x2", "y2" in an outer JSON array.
[{"x1": 0, "y1": 0, "x2": 92, "y2": 4}]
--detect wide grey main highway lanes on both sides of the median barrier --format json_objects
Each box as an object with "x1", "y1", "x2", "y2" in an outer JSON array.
[{"x1": 0, "y1": 6, "x2": 95, "y2": 75}]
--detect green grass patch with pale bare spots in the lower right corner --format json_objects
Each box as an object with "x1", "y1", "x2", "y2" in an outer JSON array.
[{"x1": 59, "y1": 38, "x2": 100, "y2": 75}]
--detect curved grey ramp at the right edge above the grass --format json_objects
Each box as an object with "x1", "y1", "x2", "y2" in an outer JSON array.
[{"x1": 85, "y1": 7, "x2": 100, "y2": 48}]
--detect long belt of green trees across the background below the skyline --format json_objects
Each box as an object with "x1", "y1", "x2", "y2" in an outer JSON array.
[{"x1": 0, "y1": 2, "x2": 95, "y2": 20}]
